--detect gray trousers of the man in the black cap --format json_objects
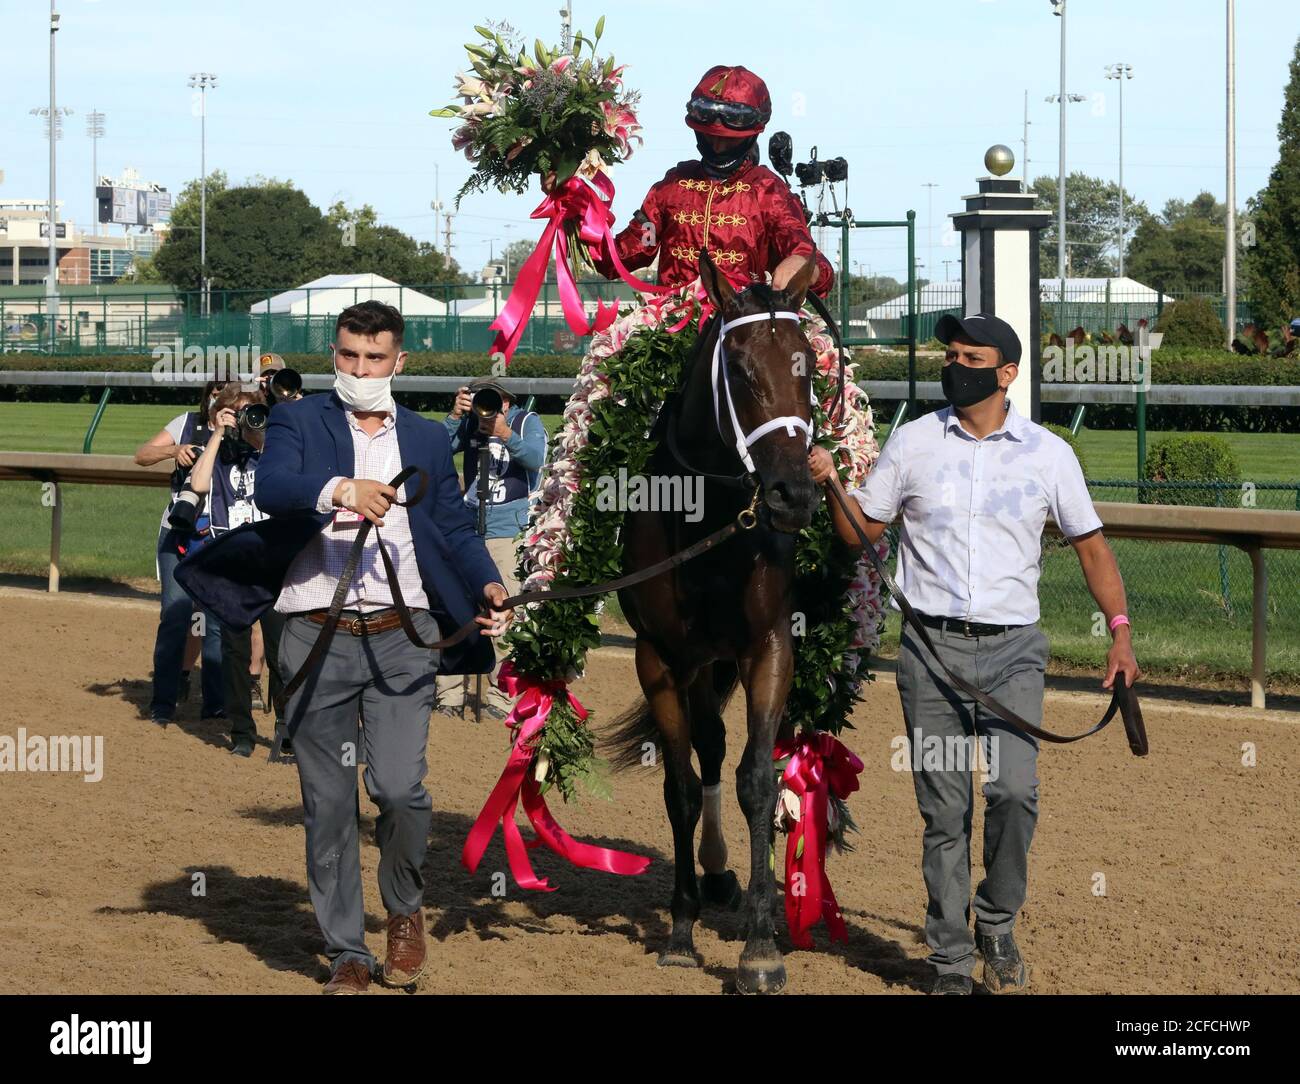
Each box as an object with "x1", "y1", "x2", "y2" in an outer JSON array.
[{"x1": 898, "y1": 625, "x2": 1048, "y2": 975}]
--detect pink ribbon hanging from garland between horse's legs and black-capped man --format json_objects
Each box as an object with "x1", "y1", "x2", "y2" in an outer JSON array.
[{"x1": 772, "y1": 732, "x2": 862, "y2": 949}]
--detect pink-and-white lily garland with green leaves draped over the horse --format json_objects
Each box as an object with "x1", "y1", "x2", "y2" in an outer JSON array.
[{"x1": 507, "y1": 281, "x2": 888, "y2": 800}]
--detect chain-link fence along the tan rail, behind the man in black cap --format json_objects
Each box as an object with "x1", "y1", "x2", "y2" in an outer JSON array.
[{"x1": 884, "y1": 481, "x2": 1300, "y2": 682}]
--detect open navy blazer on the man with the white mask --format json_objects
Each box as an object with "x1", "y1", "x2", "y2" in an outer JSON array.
[{"x1": 176, "y1": 391, "x2": 501, "y2": 673}]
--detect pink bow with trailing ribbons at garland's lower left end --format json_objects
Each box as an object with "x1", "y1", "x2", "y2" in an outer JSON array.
[{"x1": 460, "y1": 663, "x2": 650, "y2": 892}]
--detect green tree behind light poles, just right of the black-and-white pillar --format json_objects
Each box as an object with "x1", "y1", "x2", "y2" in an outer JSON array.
[{"x1": 1034, "y1": 173, "x2": 1151, "y2": 278}]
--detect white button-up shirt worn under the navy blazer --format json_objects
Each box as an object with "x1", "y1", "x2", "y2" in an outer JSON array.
[{"x1": 276, "y1": 409, "x2": 429, "y2": 613}]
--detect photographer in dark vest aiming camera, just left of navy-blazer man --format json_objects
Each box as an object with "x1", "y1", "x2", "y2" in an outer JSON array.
[{"x1": 190, "y1": 383, "x2": 285, "y2": 756}]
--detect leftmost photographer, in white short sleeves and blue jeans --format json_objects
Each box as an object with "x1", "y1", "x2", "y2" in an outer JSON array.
[{"x1": 135, "y1": 381, "x2": 225, "y2": 727}]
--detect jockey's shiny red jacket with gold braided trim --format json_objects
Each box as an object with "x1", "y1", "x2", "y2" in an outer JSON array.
[{"x1": 594, "y1": 161, "x2": 835, "y2": 298}]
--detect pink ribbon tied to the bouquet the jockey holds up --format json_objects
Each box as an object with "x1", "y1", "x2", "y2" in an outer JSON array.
[{"x1": 491, "y1": 173, "x2": 670, "y2": 364}]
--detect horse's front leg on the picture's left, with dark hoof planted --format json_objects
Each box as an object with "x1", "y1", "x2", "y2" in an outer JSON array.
[{"x1": 637, "y1": 639, "x2": 702, "y2": 967}]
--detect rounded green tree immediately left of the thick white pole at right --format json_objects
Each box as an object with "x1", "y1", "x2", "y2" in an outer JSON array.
[{"x1": 1125, "y1": 192, "x2": 1227, "y2": 292}]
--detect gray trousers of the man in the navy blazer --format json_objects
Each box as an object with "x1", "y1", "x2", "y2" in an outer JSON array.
[{"x1": 280, "y1": 610, "x2": 439, "y2": 967}]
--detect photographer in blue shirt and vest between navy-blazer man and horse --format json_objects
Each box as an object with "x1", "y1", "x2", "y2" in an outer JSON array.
[{"x1": 438, "y1": 380, "x2": 546, "y2": 719}]
